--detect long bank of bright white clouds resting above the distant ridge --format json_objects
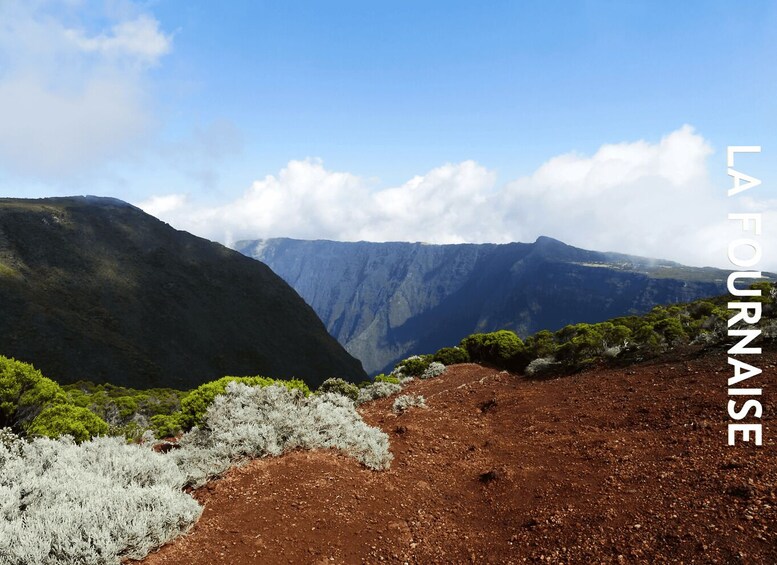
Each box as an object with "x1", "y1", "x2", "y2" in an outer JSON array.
[{"x1": 140, "y1": 126, "x2": 777, "y2": 268}]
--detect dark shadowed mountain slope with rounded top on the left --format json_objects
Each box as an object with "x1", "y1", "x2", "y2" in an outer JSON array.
[{"x1": 0, "y1": 197, "x2": 364, "y2": 388}]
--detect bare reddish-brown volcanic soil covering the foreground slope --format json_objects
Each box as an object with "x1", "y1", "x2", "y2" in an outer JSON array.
[{"x1": 135, "y1": 349, "x2": 777, "y2": 565}]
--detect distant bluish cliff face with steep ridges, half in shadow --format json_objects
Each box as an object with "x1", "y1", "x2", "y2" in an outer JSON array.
[{"x1": 236, "y1": 237, "x2": 727, "y2": 373}]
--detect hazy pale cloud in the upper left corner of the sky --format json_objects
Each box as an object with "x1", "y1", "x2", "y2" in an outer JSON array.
[{"x1": 0, "y1": 0, "x2": 172, "y2": 178}]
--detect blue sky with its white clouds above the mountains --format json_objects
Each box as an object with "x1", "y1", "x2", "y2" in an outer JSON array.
[{"x1": 0, "y1": 0, "x2": 777, "y2": 264}]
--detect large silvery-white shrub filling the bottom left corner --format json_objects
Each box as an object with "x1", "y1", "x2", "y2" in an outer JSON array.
[{"x1": 0, "y1": 434, "x2": 202, "y2": 565}]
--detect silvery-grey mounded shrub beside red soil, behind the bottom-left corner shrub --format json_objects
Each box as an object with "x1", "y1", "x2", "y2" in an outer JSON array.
[{"x1": 170, "y1": 383, "x2": 388, "y2": 485}]
